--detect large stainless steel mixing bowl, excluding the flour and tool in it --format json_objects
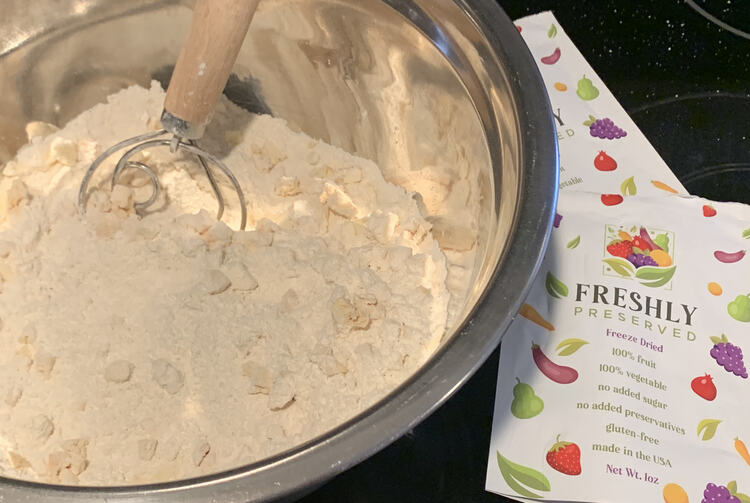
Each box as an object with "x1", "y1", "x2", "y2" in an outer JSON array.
[{"x1": 0, "y1": 0, "x2": 558, "y2": 502}]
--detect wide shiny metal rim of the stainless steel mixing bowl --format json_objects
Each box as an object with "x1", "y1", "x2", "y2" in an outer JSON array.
[{"x1": 0, "y1": 0, "x2": 559, "y2": 502}]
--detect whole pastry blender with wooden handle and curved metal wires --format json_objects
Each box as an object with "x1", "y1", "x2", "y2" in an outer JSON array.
[{"x1": 78, "y1": 0, "x2": 260, "y2": 230}]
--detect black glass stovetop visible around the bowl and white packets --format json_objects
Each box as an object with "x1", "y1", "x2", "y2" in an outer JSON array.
[{"x1": 302, "y1": 0, "x2": 750, "y2": 503}]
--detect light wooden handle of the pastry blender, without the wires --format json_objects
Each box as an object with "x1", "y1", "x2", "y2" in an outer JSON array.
[{"x1": 164, "y1": 0, "x2": 260, "y2": 139}]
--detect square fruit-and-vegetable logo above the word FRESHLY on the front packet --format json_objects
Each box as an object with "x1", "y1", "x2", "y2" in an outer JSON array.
[{"x1": 602, "y1": 224, "x2": 677, "y2": 289}]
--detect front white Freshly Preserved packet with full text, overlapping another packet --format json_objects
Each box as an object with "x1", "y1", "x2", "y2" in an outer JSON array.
[{"x1": 486, "y1": 191, "x2": 750, "y2": 503}]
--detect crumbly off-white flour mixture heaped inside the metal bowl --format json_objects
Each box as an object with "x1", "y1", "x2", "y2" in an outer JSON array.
[{"x1": 0, "y1": 85, "x2": 458, "y2": 485}]
